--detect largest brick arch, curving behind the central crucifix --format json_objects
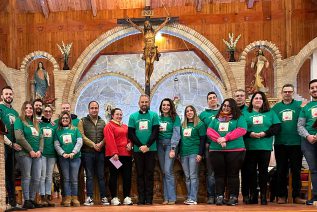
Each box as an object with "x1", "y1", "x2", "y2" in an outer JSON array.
[{"x1": 63, "y1": 24, "x2": 236, "y2": 102}]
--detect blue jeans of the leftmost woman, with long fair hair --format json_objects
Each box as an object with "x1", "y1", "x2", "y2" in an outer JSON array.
[{"x1": 17, "y1": 156, "x2": 42, "y2": 200}]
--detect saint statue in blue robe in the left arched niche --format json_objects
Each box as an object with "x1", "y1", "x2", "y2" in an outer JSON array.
[{"x1": 34, "y1": 62, "x2": 50, "y2": 99}]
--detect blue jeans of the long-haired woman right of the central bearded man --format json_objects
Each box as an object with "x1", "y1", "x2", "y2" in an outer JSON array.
[{"x1": 157, "y1": 139, "x2": 176, "y2": 202}]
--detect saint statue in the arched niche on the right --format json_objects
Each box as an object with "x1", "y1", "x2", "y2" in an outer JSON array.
[{"x1": 251, "y1": 49, "x2": 269, "y2": 92}]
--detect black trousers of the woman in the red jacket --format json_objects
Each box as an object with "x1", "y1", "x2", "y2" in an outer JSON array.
[{"x1": 106, "y1": 156, "x2": 132, "y2": 198}]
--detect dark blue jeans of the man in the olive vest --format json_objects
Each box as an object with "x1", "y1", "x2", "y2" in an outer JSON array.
[{"x1": 81, "y1": 151, "x2": 106, "y2": 198}]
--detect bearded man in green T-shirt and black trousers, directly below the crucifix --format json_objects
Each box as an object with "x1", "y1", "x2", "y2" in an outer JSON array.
[{"x1": 128, "y1": 94, "x2": 160, "y2": 205}]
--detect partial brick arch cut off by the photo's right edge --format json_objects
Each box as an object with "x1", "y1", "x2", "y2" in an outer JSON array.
[{"x1": 293, "y1": 37, "x2": 317, "y2": 79}]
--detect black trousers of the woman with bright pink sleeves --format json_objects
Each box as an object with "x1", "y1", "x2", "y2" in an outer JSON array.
[{"x1": 209, "y1": 151, "x2": 245, "y2": 197}]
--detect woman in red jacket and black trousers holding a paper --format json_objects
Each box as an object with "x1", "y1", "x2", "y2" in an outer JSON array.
[{"x1": 104, "y1": 108, "x2": 133, "y2": 205}]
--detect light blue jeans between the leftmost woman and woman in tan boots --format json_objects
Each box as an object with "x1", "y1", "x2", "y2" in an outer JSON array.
[{"x1": 40, "y1": 156, "x2": 57, "y2": 195}]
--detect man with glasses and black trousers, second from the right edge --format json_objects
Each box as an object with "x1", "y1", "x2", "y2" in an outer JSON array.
[{"x1": 272, "y1": 84, "x2": 305, "y2": 204}]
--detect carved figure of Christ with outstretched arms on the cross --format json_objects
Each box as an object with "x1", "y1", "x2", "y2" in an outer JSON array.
[{"x1": 126, "y1": 17, "x2": 170, "y2": 84}]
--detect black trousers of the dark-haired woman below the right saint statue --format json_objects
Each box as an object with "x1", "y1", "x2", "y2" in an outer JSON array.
[{"x1": 244, "y1": 150, "x2": 271, "y2": 197}]
